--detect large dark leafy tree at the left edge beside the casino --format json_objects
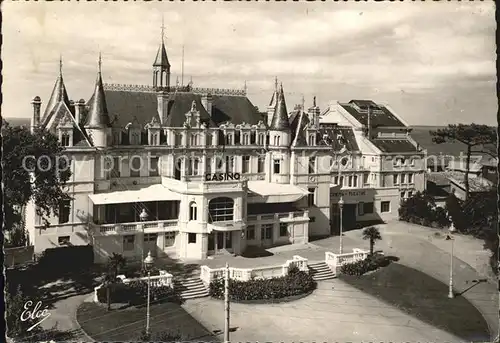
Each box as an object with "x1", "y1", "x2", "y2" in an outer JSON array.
[{"x1": 2, "y1": 121, "x2": 71, "y2": 236}]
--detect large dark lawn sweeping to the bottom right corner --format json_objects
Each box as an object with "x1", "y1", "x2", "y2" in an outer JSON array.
[{"x1": 340, "y1": 263, "x2": 490, "y2": 342}]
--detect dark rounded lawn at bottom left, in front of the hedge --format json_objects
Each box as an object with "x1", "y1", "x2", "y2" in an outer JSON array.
[{"x1": 76, "y1": 303, "x2": 220, "y2": 342}]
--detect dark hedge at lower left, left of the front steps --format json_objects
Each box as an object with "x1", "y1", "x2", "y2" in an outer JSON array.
[{"x1": 97, "y1": 281, "x2": 182, "y2": 306}]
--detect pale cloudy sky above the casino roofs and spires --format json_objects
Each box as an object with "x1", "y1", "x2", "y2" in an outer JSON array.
[{"x1": 2, "y1": 1, "x2": 497, "y2": 125}]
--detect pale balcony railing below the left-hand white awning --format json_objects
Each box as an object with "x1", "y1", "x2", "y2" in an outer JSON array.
[{"x1": 91, "y1": 219, "x2": 178, "y2": 236}]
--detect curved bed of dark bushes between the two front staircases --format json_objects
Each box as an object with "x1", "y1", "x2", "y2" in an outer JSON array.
[{"x1": 210, "y1": 267, "x2": 316, "y2": 301}]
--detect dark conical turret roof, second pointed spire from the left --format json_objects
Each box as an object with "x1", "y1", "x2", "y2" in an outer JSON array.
[{"x1": 85, "y1": 53, "x2": 111, "y2": 129}]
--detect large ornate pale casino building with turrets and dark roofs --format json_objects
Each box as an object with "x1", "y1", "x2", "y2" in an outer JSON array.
[{"x1": 25, "y1": 31, "x2": 425, "y2": 262}]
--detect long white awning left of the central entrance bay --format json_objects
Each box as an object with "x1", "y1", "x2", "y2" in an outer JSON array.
[{"x1": 89, "y1": 185, "x2": 181, "y2": 205}]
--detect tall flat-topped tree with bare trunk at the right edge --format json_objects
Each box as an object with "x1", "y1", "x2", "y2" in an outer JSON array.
[{"x1": 430, "y1": 124, "x2": 497, "y2": 198}]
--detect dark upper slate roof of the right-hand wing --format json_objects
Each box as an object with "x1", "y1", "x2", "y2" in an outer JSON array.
[{"x1": 340, "y1": 100, "x2": 405, "y2": 128}]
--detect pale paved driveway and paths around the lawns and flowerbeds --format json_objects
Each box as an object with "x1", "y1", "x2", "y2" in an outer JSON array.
[{"x1": 38, "y1": 222, "x2": 499, "y2": 342}]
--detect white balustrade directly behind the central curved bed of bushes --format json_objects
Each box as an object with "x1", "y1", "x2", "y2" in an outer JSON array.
[{"x1": 200, "y1": 256, "x2": 309, "y2": 286}]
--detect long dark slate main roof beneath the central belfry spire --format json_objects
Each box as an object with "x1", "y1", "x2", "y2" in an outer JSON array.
[{"x1": 96, "y1": 90, "x2": 262, "y2": 127}]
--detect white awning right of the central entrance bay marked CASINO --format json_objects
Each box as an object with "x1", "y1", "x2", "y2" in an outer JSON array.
[{"x1": 248, "y1": 181, "x2": 309, "y2": 203}]
